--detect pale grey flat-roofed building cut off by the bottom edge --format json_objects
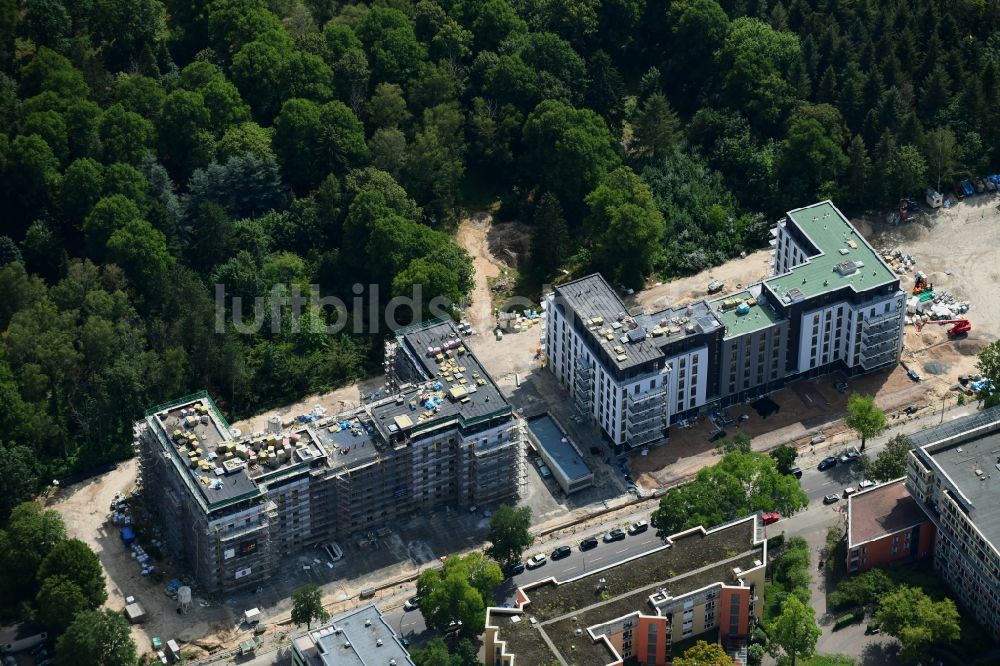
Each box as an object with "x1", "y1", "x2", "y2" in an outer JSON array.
[{"x1": 292, "y1": 606, "x2": 413, "y2": 666}]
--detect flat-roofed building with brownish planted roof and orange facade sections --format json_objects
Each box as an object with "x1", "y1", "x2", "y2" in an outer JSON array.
[{"x1": 485, "y1": 515, "x2": 767, "y2": 666}]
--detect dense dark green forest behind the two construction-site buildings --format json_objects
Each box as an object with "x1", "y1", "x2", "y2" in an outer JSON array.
[{"x1": 0, "y1": 0, "x2": 1000, "y2": 520}]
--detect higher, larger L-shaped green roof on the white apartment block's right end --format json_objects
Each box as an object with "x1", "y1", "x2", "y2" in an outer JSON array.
[{"x1": 764, "y1": 201, "x2": 899, "y2": 302}]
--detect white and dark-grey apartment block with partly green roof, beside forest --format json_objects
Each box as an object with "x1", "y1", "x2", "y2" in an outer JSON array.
[{"x1": 542, "y1": 201, "x2": 905, "y2": 451}]
